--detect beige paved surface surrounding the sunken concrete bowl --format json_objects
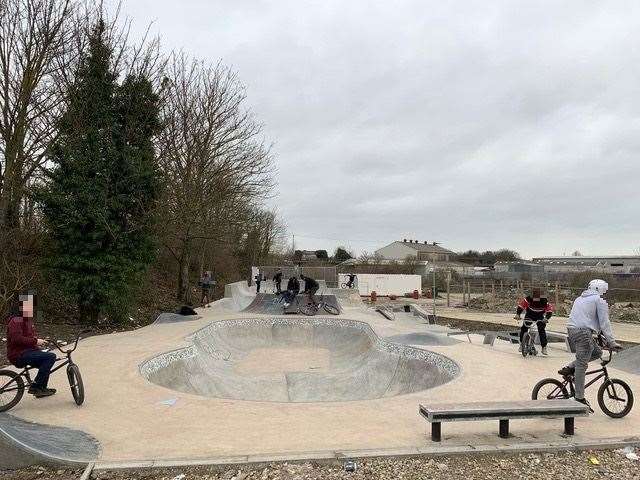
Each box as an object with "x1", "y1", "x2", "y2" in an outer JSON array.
[{"x1": 1, "y1": 296, "x2": 640, "y2": 462}]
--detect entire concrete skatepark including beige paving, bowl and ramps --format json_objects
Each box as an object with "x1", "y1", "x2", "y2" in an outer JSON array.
[{"x1": 0, "y1": 283, "x2": 640, "y2": 468}]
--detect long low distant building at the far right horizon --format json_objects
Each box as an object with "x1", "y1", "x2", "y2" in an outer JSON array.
[{"x1": 532, "y1": 255, "x2": 640, "y2": 273}]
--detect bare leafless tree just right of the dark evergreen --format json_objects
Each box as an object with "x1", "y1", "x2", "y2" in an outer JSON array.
[{"x1": 158, "y1": 54, "x2": 273, "y2": 301}]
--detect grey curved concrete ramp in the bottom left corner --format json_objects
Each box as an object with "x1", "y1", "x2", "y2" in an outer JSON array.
[{"x1": 0, "y1": 413, "x2": 100, "y2": 470}]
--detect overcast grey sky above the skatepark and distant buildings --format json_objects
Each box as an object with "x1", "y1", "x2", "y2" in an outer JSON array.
[{"x1": 107, "y1": 0, "x2": 640, "y2": 257}]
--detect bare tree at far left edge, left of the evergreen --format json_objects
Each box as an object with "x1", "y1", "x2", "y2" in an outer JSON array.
[{"x1": 0, "y1": 0, "x2": 72, "y2": 229}]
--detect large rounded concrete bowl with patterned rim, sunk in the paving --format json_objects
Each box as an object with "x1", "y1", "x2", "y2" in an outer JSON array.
[{"x1": 140, "y1": 317, "x2": 459, "y2": 403}]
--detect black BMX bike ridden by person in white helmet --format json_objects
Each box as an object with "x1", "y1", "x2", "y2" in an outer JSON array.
[{"x1": 531, "y1": 335, "x2": 633, "y2": 418}]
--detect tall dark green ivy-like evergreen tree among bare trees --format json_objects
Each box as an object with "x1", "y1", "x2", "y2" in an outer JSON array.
[{"x1": 38, "y1": 22, "x2": 159, "y2": 321}]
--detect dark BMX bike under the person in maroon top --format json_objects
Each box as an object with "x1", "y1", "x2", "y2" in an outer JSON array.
[{"x1": 0, "y1": 330, "x2": 89, "y2": 412}]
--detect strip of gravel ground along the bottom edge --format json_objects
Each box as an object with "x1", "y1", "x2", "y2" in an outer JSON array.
[{"x1": 0, "y1": 451, "x2": 640, "y2": 480}]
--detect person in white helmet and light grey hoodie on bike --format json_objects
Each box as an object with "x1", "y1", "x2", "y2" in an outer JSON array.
[{"x1": 558, "y1": 279, "x2": 622, "y2": 405}]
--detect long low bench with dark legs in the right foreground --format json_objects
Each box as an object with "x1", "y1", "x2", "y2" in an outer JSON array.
[{"x1": 419, "y1": 399, "x2": 589, "y2": 442}]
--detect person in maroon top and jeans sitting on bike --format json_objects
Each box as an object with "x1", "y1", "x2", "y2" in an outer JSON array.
[{"x1": 7, "y1": 292, "x2": 56, "y2": 398}]
